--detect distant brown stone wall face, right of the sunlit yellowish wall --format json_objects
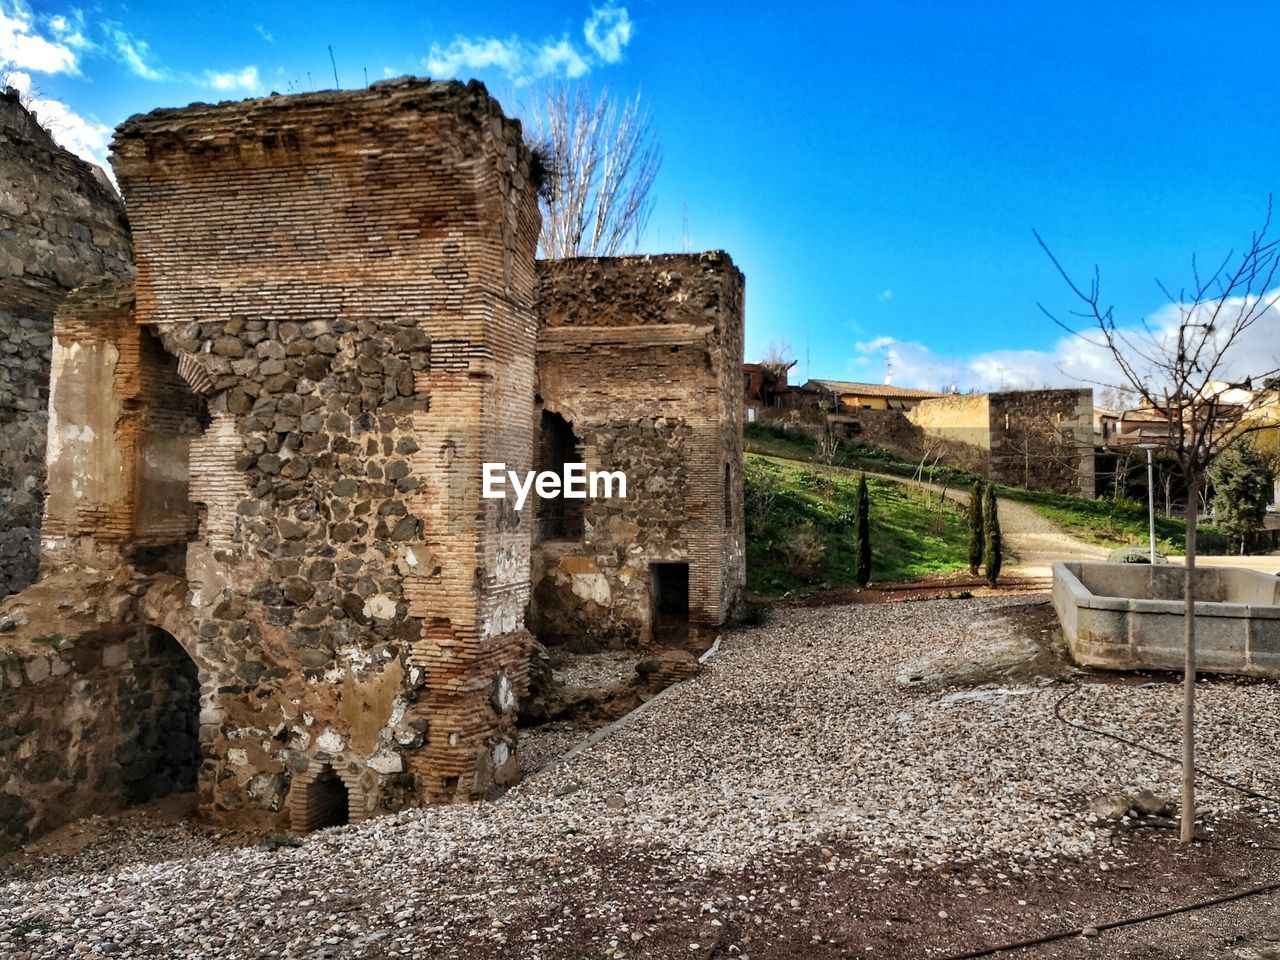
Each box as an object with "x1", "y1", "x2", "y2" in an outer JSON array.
[{"x1": 988, "y1": 388, "x2": 1094, "y2": 497}]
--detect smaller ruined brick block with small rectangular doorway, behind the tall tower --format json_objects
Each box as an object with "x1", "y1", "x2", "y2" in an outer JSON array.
[{"x1": 532, "y1": 252, "x2": 745, "y2": 644}]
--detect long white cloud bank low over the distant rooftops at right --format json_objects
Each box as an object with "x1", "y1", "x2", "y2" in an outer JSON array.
[{"x1": 849, "y1": 291, "x2": 1280, "y2": 399}]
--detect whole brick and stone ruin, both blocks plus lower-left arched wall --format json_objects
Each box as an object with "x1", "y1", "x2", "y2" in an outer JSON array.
[{"x1": 0, "y1": 79, "x2": 745, "y2": 844}]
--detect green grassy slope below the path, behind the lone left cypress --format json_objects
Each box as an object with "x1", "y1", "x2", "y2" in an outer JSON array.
[{"x1": 746, "y1": 454, "x2": 966, "y2": 598}]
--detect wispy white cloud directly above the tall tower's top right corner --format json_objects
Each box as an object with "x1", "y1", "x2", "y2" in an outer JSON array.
[{"x1": 422, "y1": 5, "x2": 631, "y2": 83}]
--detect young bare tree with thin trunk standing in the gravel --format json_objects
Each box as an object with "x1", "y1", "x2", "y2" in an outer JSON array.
[{"x1": 1036, "y1": 208, "x2": 1280, "y2": 842}]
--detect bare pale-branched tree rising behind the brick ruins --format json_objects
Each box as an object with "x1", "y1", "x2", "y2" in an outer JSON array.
[{"x1": 530, "y1": 81, "x2": 662, "y2": 257}]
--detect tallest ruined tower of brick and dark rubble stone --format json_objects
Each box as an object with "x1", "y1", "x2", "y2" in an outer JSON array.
[{"x1": 102, "y1": 81, "x2": 539, "y2": 826}]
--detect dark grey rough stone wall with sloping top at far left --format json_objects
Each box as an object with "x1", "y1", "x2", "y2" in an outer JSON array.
[{"x1": 0, "y1": 91, "x2": 132, "y2": 598}]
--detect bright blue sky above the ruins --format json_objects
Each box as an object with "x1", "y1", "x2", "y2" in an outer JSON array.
[{"x1": 0, "y1": 0, "x2": 1280, "y2": 389}]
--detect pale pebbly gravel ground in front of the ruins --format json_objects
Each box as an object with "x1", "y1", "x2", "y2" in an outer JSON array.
[{"x1": 0, "y1": 598, "x2": 1280, "y2": 960}]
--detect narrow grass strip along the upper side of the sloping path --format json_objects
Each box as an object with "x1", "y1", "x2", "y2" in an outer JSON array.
[{"x1": 744, "y1": 424, "x2": 1228, "y2": 553}]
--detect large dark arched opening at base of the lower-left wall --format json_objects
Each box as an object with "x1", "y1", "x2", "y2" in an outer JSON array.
[{"x1": 115, "y1": 626, "x2": 201, "y2": 805}]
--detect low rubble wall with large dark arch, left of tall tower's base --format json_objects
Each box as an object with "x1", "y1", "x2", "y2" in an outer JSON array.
[{"x1": 0, "y1": 593, "x2": 200, "y2": 850}]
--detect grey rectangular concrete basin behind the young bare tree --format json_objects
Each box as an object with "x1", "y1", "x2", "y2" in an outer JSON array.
[{"x1": 1053, "y1": 561, "x2": 1280, "y2": 677}]
